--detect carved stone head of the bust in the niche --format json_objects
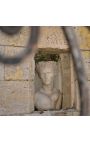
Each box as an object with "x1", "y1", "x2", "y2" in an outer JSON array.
[{"x1": 36, "y1": 61, "x2": 56, "y2": 85}]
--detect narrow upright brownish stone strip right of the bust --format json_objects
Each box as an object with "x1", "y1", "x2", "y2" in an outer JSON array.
[{"x1": 60, "y1": 53, "x2": 72, "y2": 109}]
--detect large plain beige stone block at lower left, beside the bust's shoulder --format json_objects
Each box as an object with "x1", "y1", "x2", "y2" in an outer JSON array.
[{"x1": 0, "y1": 81, "x2": 34, "y2": 115}]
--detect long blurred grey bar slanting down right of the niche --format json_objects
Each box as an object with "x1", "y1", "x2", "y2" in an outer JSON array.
[{"x1": 62, "y1": 26, "x2": 90, "y2": 115}]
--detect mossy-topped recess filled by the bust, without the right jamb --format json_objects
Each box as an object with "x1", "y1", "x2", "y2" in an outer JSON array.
[{"x1": 35, "y1": 51, "x2": 62, "y2": 112}]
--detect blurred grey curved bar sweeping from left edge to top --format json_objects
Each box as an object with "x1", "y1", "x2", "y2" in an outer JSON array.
[{"x1": 0, "y1": 26, "x2": 39, "y2": 64}]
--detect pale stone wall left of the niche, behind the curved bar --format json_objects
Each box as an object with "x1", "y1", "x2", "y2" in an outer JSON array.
[{"x1": 0, "y1": 27, "x2": 35, "y2": 115}]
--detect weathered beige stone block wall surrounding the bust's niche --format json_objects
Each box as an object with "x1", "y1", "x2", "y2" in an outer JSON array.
[{"x1": 0, "y1": 26, "x2": 90, "y2": 115}]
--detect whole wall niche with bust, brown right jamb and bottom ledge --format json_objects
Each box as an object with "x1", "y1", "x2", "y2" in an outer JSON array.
[{"x1": 34, "y1": 49, "x2": 79, "y2": 115}]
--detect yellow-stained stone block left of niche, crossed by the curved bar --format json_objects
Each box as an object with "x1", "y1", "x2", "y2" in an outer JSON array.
[{"x1": 5, "y1": 46, "x2": 35, "y2": 80}]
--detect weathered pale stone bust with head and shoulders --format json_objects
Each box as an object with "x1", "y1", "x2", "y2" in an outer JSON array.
[{"x1": 35, "y1": 61, "x2": 62, "y2": 111}]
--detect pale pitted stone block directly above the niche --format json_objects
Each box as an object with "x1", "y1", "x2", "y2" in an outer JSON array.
[{"x1": 38, "y1": 26, "x2": 68, "y2": 51}]
